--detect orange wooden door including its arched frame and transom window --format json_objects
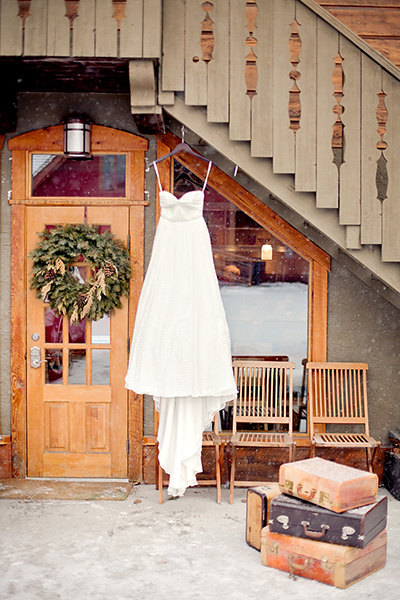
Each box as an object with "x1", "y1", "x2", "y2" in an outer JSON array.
[{"x1": 8, "y1": 125, "x2": 148, "y2": 481}]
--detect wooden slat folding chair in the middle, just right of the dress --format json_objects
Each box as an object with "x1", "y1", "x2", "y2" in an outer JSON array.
[{"x1": 229, "y1": 360, "x2": 296, "y2": 504}]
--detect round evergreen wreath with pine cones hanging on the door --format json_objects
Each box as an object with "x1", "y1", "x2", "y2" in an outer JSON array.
[{"x1": 29, "y1": 223, "x2": 131, "y2": 322}]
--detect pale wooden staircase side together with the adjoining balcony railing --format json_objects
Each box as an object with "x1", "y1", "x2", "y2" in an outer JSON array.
[{"x1": 0, "y1": 0, "x2": 400, "y2": 298}]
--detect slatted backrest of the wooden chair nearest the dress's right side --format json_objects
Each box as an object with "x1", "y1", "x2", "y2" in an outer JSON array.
[{"x1": 233, "y1": 359, "x2": 295, "y2": 434}]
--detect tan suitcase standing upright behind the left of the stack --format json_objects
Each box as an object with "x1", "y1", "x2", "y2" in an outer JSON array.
[{"x1": 246, "y1": 482, "x2": 281, "y2": 550}]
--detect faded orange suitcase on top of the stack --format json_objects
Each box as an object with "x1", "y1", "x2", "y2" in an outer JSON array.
[{"x1": 279, "y1": 458, "x2": 379, "y2": 513}]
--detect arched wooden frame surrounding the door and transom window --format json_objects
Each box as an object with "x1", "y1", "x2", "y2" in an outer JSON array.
[{"x1": 8, "y1": 125, "x2": 148, "y2": 481}]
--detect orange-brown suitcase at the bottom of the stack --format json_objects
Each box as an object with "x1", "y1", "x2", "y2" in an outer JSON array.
[{"x1": 261, "y1": 527, "x2": 387, "y2": 588}]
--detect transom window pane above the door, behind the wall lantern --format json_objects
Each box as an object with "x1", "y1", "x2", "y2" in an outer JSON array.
[{"x1": 32, "y1": 154, "x2": 126, "y2": 198}]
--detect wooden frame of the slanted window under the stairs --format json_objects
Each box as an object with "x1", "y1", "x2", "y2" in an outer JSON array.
[{"x1": 157, "y1": 132, "x2": 330, "y2": 445}]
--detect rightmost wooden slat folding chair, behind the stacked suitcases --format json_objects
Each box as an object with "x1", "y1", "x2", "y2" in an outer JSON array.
[{"x1": 307, "y1": 362, "x2": 380, "y2": 472}]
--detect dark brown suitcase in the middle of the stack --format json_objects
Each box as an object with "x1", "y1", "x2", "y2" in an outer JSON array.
[{"x1": 268, "y1": 494, "x2": 387, "y2": 548}]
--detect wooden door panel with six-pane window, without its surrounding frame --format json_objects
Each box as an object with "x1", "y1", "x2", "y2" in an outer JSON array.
[{"x1": 26, "y1": 206, "x2": 129, "y2": 478}]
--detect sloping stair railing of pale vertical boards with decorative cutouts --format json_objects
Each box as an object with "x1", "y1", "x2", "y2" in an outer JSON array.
[{"x1": 162, "y1": 0, "x2": 400, "y2": 262}]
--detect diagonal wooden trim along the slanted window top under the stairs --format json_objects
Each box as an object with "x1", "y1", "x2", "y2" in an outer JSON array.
[{"x1": 157, "y1": 132, "x2": 330, "y2": 271}]
